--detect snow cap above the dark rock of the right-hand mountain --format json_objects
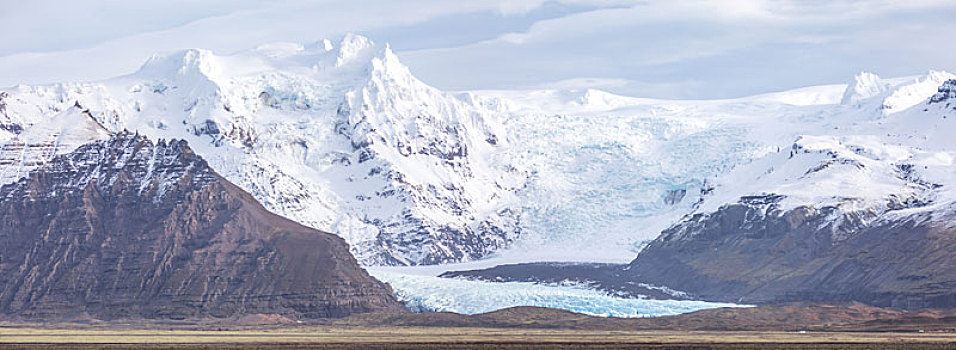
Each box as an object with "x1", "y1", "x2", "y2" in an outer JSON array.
[{"x1": 694, "y1": 72, "x2": 956, "y2": 238}]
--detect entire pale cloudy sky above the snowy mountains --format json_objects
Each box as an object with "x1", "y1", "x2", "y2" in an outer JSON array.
[{"x1": 0, "y1": 0, "x2": 956, "y2": 99}]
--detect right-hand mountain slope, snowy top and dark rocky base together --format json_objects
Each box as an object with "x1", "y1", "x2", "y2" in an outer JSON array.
[{"x1": 627, "y1": 75, "x2": 956, "y2": 308}]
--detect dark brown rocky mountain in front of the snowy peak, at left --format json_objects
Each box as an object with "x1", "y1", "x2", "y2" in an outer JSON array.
[{"x1": 0, "y1": 133, "x2": 400, "y2": 319}]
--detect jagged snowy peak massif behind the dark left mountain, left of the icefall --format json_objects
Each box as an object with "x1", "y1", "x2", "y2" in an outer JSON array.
[{"x1": 0, "y1": 35, "x2": 522, "y2": 264}]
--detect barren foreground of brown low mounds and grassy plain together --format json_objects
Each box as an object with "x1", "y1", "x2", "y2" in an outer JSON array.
[{"x1": 0, "y1": 304, "x2": 956, "y2": 349}]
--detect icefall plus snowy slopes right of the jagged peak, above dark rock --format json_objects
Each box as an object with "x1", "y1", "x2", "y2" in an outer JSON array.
[{"x1": 475, "y1": 72, "x2": 956, "y2": 262}]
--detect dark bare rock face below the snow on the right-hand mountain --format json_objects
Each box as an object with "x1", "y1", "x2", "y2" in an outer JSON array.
[{"x1": 627, "y1": 197, "x2": 956, "y2": 309}]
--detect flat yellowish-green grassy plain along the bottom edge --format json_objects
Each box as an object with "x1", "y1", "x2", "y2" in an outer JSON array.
[{"x1": 0, "y1": 326, "x2": 956, "y2": 349}]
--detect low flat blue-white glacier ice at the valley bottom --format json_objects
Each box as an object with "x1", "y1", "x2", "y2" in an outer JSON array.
[{"x1": 369, "y1": 268, "x2": 750, "y2": 318}]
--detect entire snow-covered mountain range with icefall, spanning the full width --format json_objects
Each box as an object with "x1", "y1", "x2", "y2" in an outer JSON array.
[{"x1": 0, "y1": 35, "x2": 956, "y2": 265}]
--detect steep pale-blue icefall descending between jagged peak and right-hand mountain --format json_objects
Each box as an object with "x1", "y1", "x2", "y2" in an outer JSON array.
[{"x1": 492, "y1": 109, "x2": 759, "y2": 262}]
